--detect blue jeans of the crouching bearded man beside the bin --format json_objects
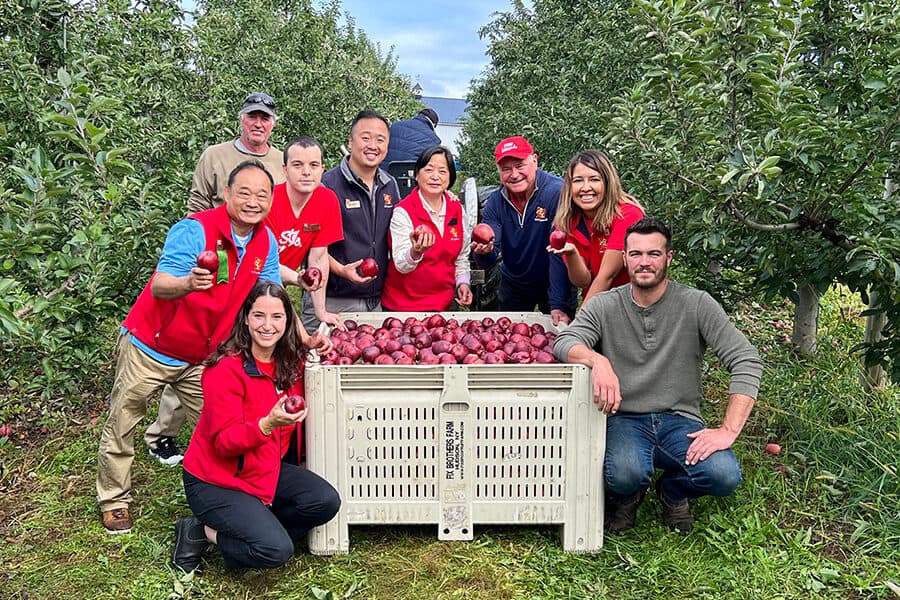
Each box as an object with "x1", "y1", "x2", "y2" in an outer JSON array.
[{"x1": 603, "y1": 413, "x2": 741, "y2": 505}]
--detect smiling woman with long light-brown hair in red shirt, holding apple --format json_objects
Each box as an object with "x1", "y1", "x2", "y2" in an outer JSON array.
[{"x1": 547, "y1": 150, "x2": 644, "y2": 302}]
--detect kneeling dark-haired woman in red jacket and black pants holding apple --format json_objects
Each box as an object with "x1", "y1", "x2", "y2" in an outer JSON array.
[{"x1": 172, "y1": 281, "x2": 340, "y2": 572}]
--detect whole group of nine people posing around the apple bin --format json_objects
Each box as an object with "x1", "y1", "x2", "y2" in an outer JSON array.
[{"x1": 97, "y1": 93, "x2": 761, "y2": 572}]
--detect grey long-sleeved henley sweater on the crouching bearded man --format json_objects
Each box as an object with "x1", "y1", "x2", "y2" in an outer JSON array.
[{"x1": 553, "y1": 281, "x2": 762, "y2": 420}]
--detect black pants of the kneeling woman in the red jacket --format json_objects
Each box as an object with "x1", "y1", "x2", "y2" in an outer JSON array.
[{"x1": 183, "y1": 463, "x2": 341, "y2": 569}]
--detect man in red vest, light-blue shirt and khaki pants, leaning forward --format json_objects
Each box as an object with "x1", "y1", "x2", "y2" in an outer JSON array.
[{"x1": 97, "y1": 160, "x2": 281, "y2": 533}]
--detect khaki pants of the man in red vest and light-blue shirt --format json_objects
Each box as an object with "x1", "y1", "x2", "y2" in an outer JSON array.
[{"x1": 97, "y1": 333, "x2": 203, "y2": 511}]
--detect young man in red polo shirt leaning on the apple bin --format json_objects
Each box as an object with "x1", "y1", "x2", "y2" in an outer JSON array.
[{"x1": 266, "y1": 136, "x2": 344, "y2": 330}]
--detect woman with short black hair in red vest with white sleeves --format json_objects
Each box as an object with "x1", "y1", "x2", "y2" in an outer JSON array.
[{"x1": 381, "y1": 146, "x2": 472, "y2": 311}]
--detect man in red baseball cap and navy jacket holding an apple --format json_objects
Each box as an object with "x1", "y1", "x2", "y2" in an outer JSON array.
[{"x1": 471, "y1": 135, "x2": 576, "y2": 325}]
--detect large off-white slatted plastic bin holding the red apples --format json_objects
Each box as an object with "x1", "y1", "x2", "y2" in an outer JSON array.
[{"x1": 305, "y1": 312, "x2": 606, "y2": 555}]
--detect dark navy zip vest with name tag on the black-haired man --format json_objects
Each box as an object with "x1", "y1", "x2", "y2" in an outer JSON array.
[{"x1": 322, "y1": 157, "x2": 401, "y2": 299}]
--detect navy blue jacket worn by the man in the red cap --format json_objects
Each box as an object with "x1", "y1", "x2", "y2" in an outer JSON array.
[{"x1": 473, "y1": 169, "x2": 574, "y2": 313}]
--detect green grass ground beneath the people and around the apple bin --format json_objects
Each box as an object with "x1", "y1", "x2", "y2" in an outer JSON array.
[{"x1": 0, "y1": 291, "x2": 900, "y2": 600}]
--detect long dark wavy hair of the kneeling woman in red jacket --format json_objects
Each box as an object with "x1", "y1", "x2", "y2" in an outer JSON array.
[{"x1": 203, "y1": 280, "x2": 304, "y2": 390}]
